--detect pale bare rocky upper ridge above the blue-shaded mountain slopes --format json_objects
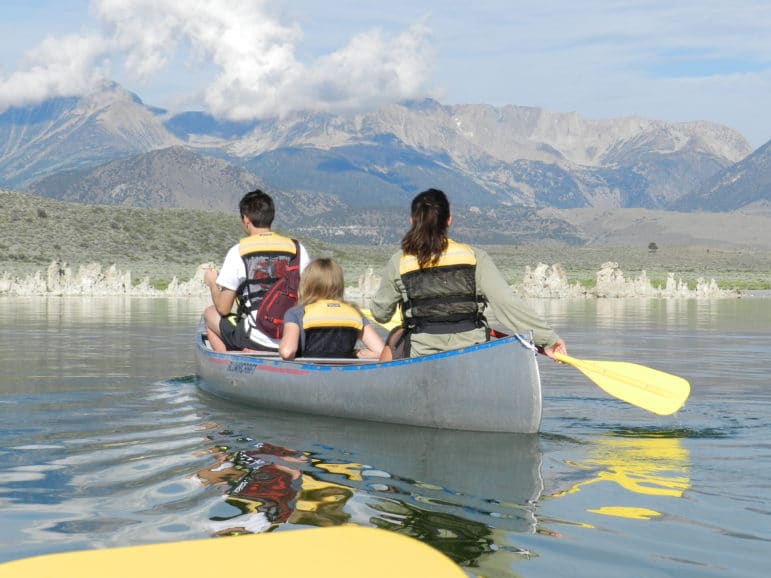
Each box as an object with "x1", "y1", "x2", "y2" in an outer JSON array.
[{"x1": 213, "y1": 100, "x2": 751, "y2": 167}]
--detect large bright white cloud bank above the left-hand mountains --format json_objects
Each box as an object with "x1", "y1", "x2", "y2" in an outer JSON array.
[{"x1": 0, "y1": 0, "x2": 431, "y2": 120}]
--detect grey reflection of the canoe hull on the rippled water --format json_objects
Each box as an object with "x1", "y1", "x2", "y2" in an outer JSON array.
[{"x1": 199, "y1": 399, "x2": 544, "y2": 538}]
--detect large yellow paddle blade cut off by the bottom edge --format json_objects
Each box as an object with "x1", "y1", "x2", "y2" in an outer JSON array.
[{"x1": 0, "y1": 526, "x2": 466, "y2": 578}]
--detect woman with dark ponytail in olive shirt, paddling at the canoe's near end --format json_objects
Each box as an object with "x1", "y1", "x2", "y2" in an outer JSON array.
[{"x1": 370, "y1": 189, "x2": 567, "y2": 361}]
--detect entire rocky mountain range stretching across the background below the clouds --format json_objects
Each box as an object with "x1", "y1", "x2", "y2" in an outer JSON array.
[{"x1": 0, "y1": 84, "x2": 771, "y2": 242}]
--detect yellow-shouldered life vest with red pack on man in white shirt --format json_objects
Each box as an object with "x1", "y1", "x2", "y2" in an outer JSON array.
[{"x1": 237, "y1": 231, "x2": 300, "y2": 338}]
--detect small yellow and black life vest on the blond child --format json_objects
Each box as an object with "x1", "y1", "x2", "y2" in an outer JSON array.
[{"x1": 299, "y1": 299, "x2": 364, "y2": 358}]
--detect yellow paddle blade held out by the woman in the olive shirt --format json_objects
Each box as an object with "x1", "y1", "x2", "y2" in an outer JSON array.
[{"x1": 556, "y1": 354, "x2": 691, "y2": 415}]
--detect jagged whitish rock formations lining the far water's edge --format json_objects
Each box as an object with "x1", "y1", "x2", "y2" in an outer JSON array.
[{"x1": 0, "y1": 261, "x2": 742, "y2": 305}]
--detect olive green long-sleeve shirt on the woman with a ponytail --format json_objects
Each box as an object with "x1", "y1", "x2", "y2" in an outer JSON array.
[{"x1": 370, "y1": 247, "x2": 559, "y2": 357}]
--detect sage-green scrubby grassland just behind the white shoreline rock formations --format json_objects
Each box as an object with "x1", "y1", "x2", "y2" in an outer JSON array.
[{"x1": 0, "y1": 190, "x2": 771, "y2": 289}]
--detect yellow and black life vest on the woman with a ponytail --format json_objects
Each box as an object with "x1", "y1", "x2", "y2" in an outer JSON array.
[{"x1": 399, "y1": 240, "x2": 485, "y2": 333}]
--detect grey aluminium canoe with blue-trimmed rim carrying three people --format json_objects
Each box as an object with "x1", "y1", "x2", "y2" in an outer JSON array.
[{"x1": 195, "y1": 326, "x2": 542, "y2": 433}]
